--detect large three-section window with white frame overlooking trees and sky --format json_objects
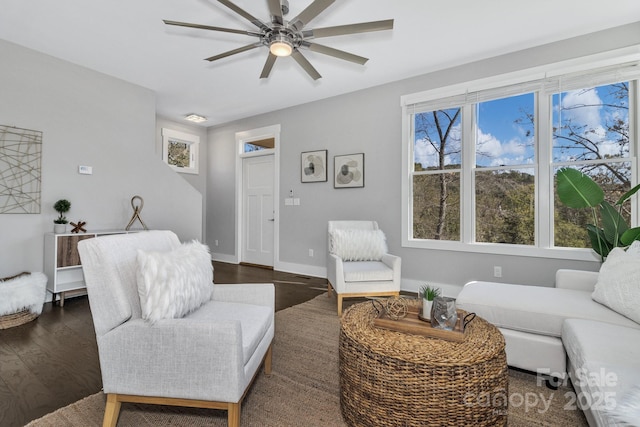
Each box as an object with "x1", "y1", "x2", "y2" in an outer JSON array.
[{"x1": 402, "y1": 61, "x2": 640, "y2": 259}]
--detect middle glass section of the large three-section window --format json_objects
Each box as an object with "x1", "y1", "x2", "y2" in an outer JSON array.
[{"x1": 474, "y1": 93, "x2": 537, "y2": 245}]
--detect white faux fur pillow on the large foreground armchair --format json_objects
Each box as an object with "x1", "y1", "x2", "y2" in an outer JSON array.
[{"x1": 137, "y1": 240, "x2": 213, "y2": 322}]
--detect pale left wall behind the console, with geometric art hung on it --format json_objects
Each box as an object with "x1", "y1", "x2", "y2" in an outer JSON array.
[{"x1": 0, "y1": 40, "x2": 203, "y2": 277}]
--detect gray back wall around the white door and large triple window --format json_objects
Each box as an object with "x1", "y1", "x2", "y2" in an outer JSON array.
[{"x1": 207, "y1": 23, "x2": 640, "y2": 289}]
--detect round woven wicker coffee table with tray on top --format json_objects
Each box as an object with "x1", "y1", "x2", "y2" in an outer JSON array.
[{"x1": 339, "y1": 300, "x2": 509, "y2": 426}]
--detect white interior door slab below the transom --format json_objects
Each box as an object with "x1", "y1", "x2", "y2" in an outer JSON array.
[{"x1": 242, "y1": 155, "x2": 274, "y2": 267}]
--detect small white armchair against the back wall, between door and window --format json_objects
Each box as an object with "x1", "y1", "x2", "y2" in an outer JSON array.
[{"x1": 327, "y1": 221, "x2": 401, "y2": 316}]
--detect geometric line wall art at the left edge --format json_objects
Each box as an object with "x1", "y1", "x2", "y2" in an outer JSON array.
[{"x1": 0, "y1": 125, "x2": 42, "y2": 214}]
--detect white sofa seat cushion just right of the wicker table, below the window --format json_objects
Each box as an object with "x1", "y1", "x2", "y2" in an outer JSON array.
[{"x1": 456, "y1": 282, "x2": 640, "y2": 337}]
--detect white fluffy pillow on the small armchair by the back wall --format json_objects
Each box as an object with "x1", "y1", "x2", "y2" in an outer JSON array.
[{"x1": 329, "y1": 229, "x2": 388, "y2": 261}]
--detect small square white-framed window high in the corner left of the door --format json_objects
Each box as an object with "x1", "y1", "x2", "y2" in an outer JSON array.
[{"x1": 162, "y1": 128, "x2": 200, "y2": 174}]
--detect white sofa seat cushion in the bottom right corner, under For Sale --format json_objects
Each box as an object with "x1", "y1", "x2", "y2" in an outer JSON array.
[{"x1": 562, "y1": 319, "x2": 640, "y2": 426}]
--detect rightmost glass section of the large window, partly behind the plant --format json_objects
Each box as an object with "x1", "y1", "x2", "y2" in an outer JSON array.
[{"x1": 552, "y1": 82, "x2": 632, "y2": 248}]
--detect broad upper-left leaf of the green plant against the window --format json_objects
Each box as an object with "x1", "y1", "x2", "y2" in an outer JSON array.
[{"x1": 556, "y1": 168, "x2": 604, "y2": 209}]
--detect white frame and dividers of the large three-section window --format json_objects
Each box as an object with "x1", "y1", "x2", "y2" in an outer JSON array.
[{"x1": 401, "y1": 54, "x2": 640, "y2": 261}]
